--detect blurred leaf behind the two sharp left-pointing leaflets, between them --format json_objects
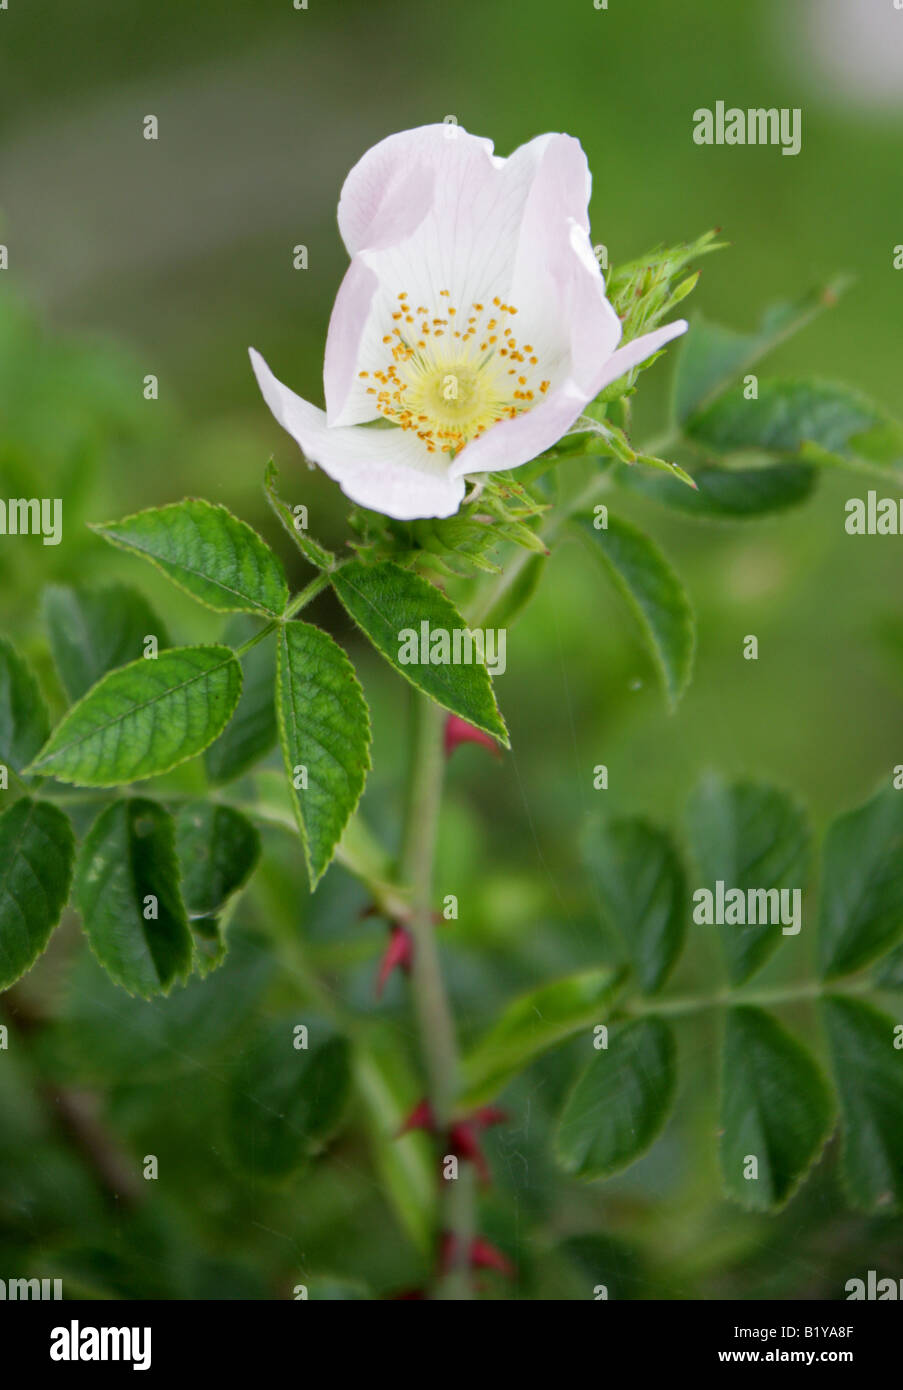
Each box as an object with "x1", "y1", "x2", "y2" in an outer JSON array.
[{"x1": 43, "y1": 584, "x2": 169, "y2": 701}]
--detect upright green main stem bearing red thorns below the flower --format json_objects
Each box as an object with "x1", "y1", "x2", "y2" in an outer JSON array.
[{"x1": 400, "y1": 694, "x2": 475, "y2": 1300}]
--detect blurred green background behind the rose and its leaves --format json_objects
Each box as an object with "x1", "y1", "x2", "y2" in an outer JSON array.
[{"x1": 0, "y1": 0, "x2": 903, "y2": 1298}]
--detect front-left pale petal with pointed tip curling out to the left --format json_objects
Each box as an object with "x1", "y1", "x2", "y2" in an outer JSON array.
[{"x1": 250, "y1": 348, "x2": 464, "y2": 521}]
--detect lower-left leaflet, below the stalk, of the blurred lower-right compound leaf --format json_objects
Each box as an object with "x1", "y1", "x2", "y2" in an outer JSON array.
[{"x1": 556, "y1": 1019, "x2": 677, "y2": 1179}]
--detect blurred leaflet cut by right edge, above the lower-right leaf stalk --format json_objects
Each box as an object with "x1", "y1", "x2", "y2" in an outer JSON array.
[{"x1": 818, "y1": 788, "x2": 903, "y2": 980}]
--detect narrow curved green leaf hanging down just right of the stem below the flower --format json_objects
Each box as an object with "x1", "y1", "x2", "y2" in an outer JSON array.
[{"x1": 572, "y1": 516, "x2": 696, "y2": 709}]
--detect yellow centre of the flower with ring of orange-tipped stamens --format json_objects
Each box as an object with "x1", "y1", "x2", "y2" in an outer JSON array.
[{"x1": 360, "y1": 289, "x2": 550, "y2": 455}]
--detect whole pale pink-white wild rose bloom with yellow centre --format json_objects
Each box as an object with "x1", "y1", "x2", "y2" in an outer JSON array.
[{"x1": 251, "y1": 124, "x2": 686, "y2": 520}]
